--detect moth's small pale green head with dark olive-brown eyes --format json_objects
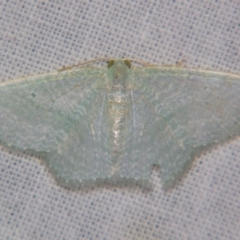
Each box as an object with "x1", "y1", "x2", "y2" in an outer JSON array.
[{"x1": 108, "y1": 60, "x2": 131, "y2": 79}]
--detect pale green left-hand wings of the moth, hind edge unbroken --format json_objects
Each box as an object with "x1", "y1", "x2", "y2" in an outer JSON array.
[{"x1": 0, "y1": 68, "x2": 110, "y2": 182}]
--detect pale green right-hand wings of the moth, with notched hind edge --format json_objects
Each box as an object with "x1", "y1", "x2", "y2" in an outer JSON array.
[{"x1": 124, "y1": 68, "x2": 240, "y2": 187}]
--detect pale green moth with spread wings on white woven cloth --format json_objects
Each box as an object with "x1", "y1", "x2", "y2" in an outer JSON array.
[{"x1": 0, "y1": 60, "x2": 240, "y2": 187}]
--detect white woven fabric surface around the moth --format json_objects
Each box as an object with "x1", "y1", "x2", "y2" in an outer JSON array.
[{"x1": 0, "y1": 0, "x2": 240, "y2": 240}]
